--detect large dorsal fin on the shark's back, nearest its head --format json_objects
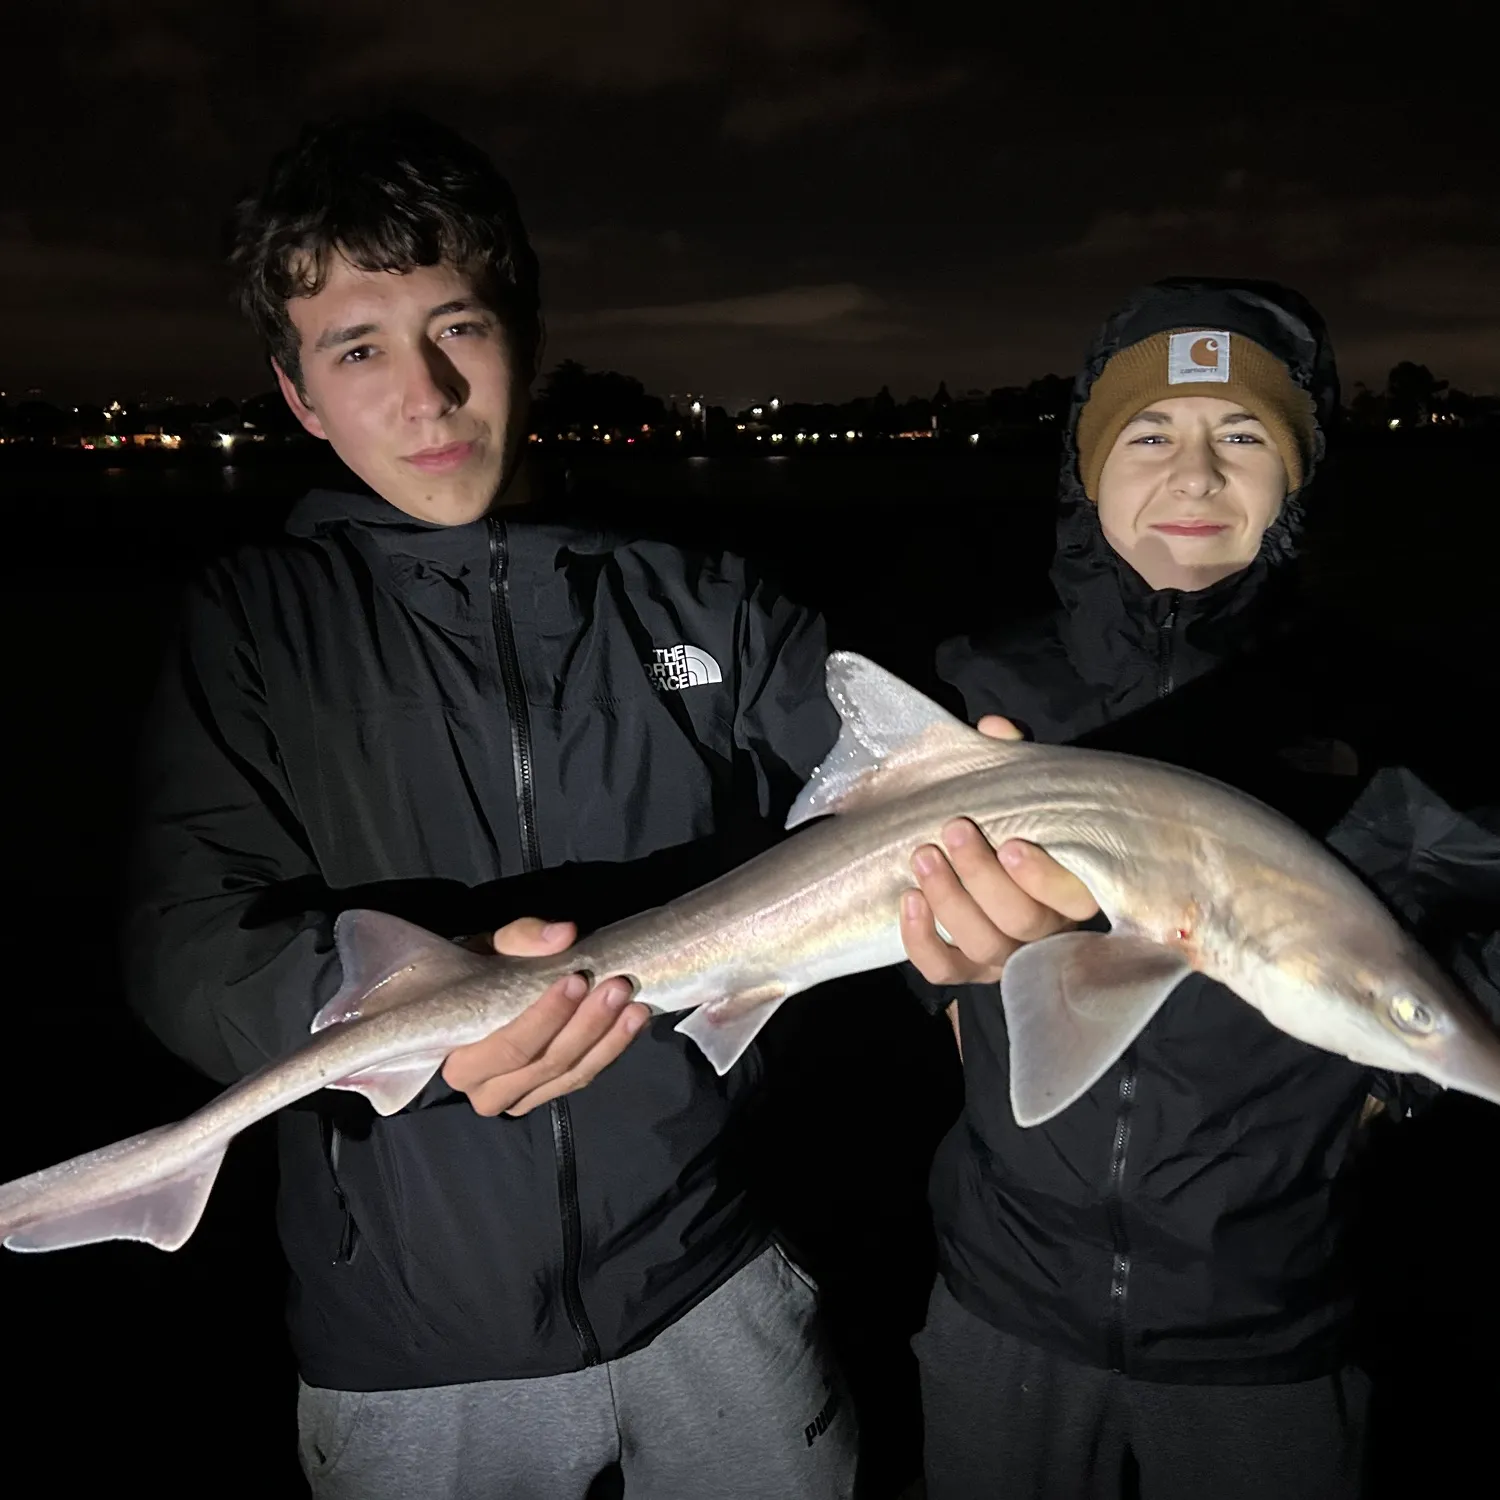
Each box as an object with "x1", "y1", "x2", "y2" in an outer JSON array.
[{"x1": 786, "y1": 651, "x2": 1016, "y2": 828}]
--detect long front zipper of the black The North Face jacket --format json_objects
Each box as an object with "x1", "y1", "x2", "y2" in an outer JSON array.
[{"x1": 489, "y1": 516, "x2": 600, "y2": 1365}]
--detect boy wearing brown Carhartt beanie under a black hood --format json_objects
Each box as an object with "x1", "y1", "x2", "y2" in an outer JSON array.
[{"x1": 914, "y1": 281, "x2": 1500, "y2": 1500}]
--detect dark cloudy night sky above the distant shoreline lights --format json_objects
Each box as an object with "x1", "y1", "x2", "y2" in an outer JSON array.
[{"x1": 0, "y1": 0, "x2": 1500, "y2": 405}]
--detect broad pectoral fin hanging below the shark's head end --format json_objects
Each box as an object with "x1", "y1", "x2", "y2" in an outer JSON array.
[{"x1": 1001, "y1": 933, "x2": 1193, "y2": 1127}]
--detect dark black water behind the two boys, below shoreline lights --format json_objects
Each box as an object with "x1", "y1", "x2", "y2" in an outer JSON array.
[{"x1": 0, "y1": 446, "x2": 1500, "y2": 1496}]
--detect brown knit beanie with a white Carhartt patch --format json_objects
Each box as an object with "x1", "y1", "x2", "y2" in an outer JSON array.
[{"x1": 1077, "y1": 329, "x2": 1317, "y2": 501}]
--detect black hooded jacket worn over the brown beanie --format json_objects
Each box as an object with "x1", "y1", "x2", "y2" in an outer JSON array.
[{"x1": 932, "y1": 281, "x2": 1500, "y2": 1383}]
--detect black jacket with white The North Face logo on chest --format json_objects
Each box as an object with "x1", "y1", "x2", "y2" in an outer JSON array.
[{"x1": 126, "y1": 492, "x2": 837, "y2": 1391}]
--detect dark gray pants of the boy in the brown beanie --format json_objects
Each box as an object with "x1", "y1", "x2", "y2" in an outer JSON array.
[{"x1": 912, "y1": 1277, "x2": 1370, "y2": 1500}]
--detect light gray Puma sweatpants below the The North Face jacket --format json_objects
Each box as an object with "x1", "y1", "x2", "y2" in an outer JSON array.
[{"x1": 297, "y1": 1248, "x2": 855, "y2": 1500}]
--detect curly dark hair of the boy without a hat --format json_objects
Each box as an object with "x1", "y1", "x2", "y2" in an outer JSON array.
[{"x1": 228, "y1": 110, "x2": 542, "y2": 387}]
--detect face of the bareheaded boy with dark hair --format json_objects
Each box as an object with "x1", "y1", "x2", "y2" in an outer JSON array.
[{"x1": 276, "y1": 257, "x2": 531, "y2": 527}]
